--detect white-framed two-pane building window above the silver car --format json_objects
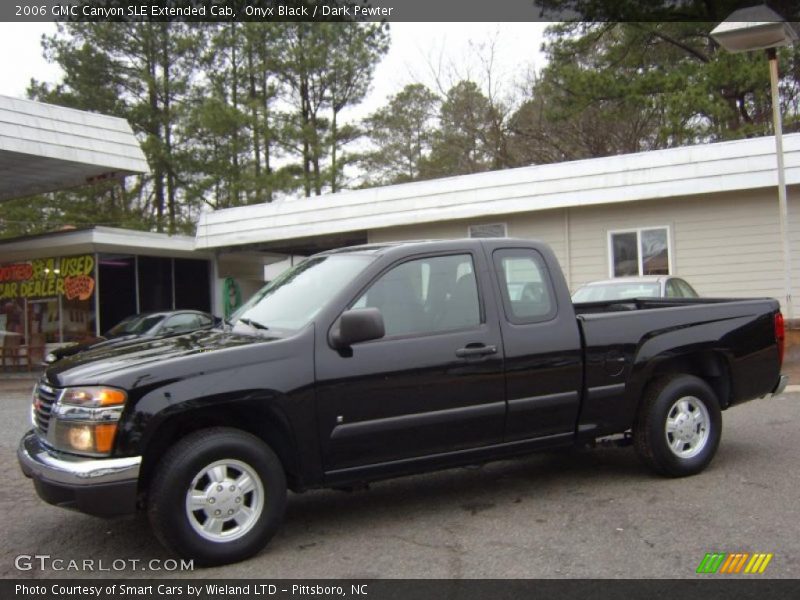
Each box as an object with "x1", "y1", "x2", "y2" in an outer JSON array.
[{"x1": 608, "y1": 227, "x2": 672, "y2": 277}]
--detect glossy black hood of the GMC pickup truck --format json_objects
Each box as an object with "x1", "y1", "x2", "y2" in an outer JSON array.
[{"x1": 44, "y1": 329, "x2": 288, "y2": 389}]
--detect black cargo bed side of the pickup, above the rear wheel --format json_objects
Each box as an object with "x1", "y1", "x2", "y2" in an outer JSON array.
[{"x1": 574, "y1": 298, "x2": 781, "y2": 437}]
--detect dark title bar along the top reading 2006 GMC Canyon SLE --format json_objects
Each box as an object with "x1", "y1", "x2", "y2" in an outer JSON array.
[{"x1": 0, "y1": 0, "x2": 800, "y2": 22}]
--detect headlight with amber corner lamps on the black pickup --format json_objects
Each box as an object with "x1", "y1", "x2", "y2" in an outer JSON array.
[{"x1": 47, "y1": 386, "x2": 127, "y2": 456}]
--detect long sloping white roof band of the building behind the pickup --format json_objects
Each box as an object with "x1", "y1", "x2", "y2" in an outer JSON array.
[{"x1": 196, "y1": 134, "x2": 800, "y2": 248}]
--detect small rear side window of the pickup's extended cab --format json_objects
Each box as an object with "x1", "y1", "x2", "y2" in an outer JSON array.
[{"x1": 494, "y1": 249, "x2": 556, "y2": 324}]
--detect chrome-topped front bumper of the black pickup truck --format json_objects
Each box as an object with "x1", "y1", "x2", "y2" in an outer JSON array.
[{"x1": 17, "y1": 430, "x2": 142, "y2": 517}]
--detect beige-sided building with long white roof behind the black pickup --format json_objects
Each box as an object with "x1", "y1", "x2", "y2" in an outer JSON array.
[{"x1": 196, "y1": 134, "x2": 800, "y2": 314}]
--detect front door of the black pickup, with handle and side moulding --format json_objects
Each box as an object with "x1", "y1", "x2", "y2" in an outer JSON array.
[{"x1": 315, "y1": 244, "x2": 506, "y2": 480}]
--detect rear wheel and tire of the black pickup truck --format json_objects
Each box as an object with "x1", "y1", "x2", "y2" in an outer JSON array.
[{"x1": 633, "y1": 375, "x2": 722, "y2": 477}]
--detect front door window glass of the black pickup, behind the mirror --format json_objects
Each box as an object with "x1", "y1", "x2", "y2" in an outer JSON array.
[{"x1": 352, "y1": 254, "x2": 481, "y2": 336}]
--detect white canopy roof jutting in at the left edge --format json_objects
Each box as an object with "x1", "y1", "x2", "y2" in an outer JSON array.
[{"x1": 0, "y1": 96, "x2": 148, "y2": 201}]
